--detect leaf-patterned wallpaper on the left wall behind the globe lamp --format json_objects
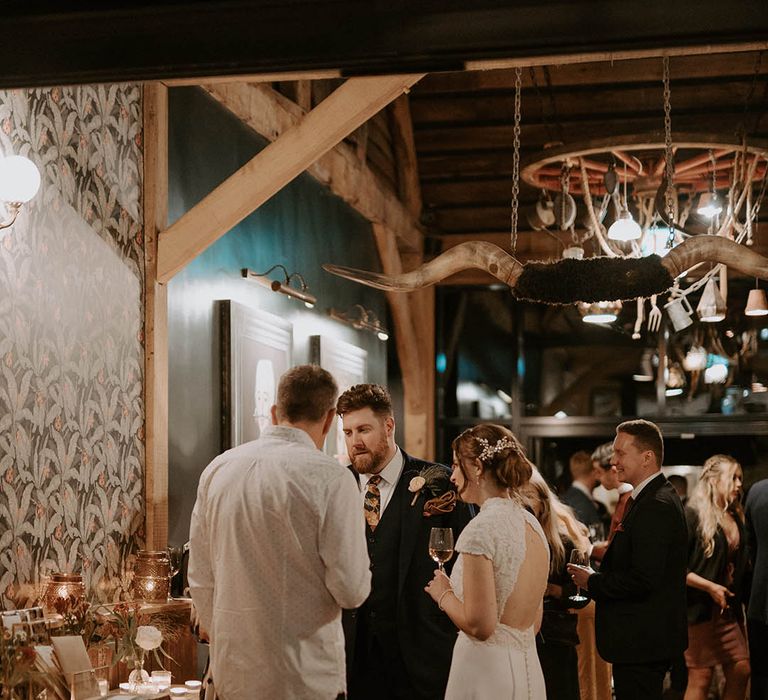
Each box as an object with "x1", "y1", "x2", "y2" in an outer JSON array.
[{"x1": 0, "y1": 85, "x2": 144, "y2": 607}]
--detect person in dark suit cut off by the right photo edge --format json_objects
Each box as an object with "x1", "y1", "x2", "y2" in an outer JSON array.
[{"x1": 744, "y1": 479, "x2": 768, "y2": 700}]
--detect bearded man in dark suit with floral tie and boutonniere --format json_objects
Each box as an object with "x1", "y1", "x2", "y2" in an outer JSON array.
[{"x1": 337, "y1": 384, "x2": 471, "y2": 700}]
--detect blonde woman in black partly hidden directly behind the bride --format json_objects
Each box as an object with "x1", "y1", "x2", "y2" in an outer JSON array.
[{"x1": 525, "y1": 470, "x2": 590, "y2": 700}]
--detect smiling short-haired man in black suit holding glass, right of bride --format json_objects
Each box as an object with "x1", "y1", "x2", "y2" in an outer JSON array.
[{"x1": 568, "y1": 420, "x2": 688, "y2": 700}]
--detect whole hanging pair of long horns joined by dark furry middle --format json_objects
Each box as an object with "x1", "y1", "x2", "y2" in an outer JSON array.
[{"x1": 323, "y1": 236, "x2": 768, "y2": 304}]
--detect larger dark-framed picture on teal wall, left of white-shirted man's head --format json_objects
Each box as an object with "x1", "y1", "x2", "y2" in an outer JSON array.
[{"x1": 224, "y1": 300, "x2": 293, "y2": 450}]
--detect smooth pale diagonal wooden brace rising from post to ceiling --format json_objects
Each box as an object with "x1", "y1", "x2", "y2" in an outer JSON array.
[{"x1": 158, "y1": 75, "x2": 422, "y2": 283}]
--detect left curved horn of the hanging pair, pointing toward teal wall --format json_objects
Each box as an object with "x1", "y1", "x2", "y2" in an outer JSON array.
[{"x1": 323, "y1": 241, "x2": 523, "y2": 292}]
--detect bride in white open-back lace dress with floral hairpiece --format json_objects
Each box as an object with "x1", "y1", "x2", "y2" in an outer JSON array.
[{"x1": 426, "y1": 424, "x2": 549, "y2": 700}]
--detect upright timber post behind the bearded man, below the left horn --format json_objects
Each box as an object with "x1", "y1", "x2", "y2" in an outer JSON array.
[{"x1": 372, "y1": 224, "x2": 435, "y2": 459}]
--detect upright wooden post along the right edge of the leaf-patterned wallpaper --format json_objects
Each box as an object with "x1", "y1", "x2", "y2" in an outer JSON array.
[{"x1": 144, "y1": 83, "x2": 168, "y2": 550}]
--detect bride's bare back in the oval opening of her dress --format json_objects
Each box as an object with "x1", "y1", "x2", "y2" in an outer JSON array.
[{"x1": 500, "y1": 520, "x2": 549, "y2": 630}]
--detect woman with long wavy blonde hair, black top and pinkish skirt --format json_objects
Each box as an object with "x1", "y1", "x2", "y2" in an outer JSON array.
[{"x1": 685, "y1": 455, "x2": 750, "y2": 700}]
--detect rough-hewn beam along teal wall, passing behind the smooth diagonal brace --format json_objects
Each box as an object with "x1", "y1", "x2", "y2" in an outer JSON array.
[{"x1": 204, "y1": 83, "x2": 423, "y2": 252}]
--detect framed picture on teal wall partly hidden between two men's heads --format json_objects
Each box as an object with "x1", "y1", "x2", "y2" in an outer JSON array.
[{"x1": 309, "y1": 335, "x2": 368, "y2": 465}]
